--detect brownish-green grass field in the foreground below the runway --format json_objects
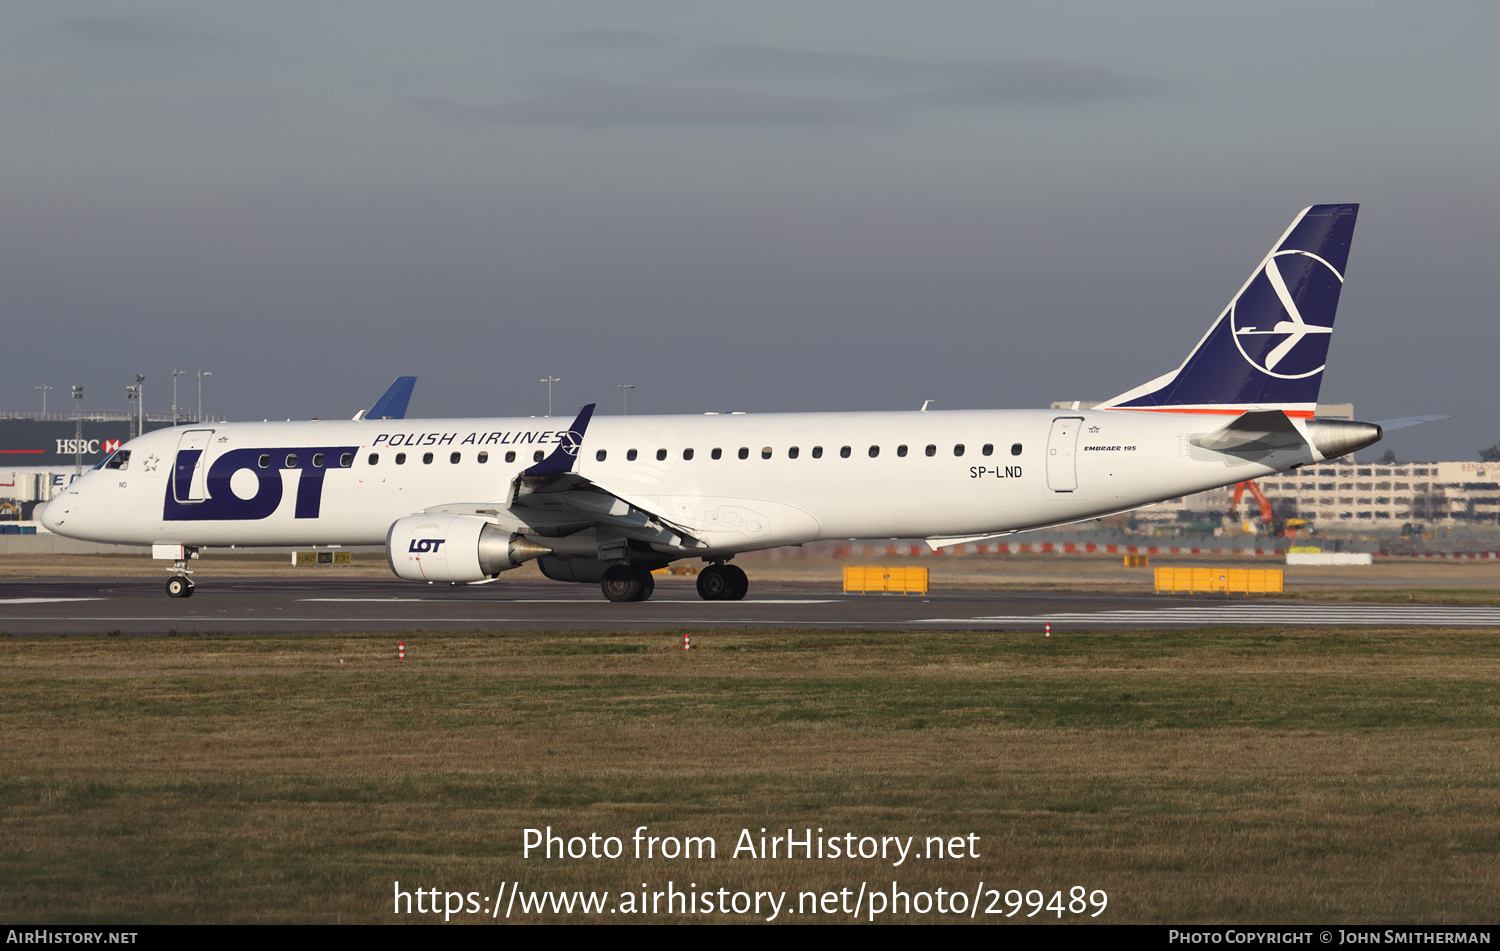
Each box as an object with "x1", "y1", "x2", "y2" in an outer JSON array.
[{"x1": 0, "y1": 630, "x2": 1500, "y2": 923}]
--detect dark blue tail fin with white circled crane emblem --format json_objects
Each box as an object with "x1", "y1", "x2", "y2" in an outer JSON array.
[{"x1": 1100, "y1": 204, "x2": 1359, "y2": 416}]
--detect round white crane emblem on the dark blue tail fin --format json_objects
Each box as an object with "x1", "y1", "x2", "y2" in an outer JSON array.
[{"x1": 1230, "y1": 251, "x2": 1344, "y2": 380}]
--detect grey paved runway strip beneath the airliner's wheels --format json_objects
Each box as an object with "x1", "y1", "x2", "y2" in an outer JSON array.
[{"x1": 0, "y1": 578, "x2": 1500, "y2": 635}]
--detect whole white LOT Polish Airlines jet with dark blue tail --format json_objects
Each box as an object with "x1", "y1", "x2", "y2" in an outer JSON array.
[{"x1": 42, "y1": 204, "x2": 1382, "y2": 602}]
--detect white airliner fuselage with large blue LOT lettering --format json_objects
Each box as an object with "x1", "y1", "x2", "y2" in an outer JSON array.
[{"x1": 47, "y1": 410, "x2": 1314, "y2": 555}]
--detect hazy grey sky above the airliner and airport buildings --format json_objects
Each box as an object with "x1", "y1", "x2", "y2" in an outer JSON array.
[{"x1": 0, "y1": 0, "x2": 1500, "y2": 458}]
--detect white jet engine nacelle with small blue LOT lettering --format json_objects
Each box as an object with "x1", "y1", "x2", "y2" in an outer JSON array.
[{"x1": 386, "y1": 513, "x2": 552, "y2": 584}]
